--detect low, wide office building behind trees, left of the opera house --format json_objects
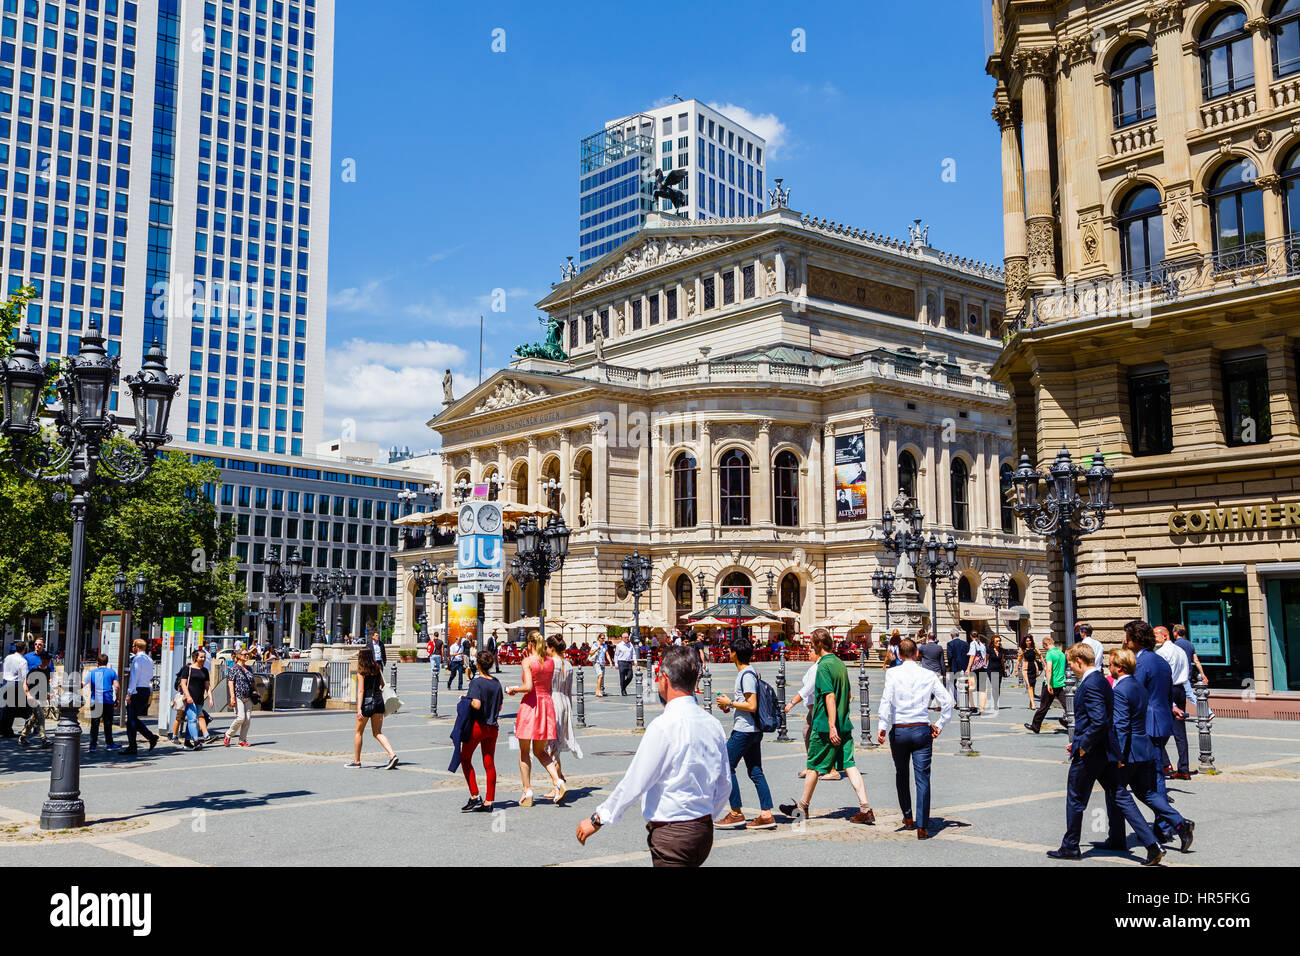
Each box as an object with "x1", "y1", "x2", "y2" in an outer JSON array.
[{"x1": 178, "y1": 442, "x2": 434, "y2": 646}]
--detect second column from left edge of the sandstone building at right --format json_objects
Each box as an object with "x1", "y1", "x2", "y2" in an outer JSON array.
[{"x1": 1013, "y1": 47, "x2": 1056, "y2": 286}]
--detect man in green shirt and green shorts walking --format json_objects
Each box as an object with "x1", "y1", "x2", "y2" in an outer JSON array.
[{"x1": 781, "y1": 627, "x2": 876, "y2": 826}]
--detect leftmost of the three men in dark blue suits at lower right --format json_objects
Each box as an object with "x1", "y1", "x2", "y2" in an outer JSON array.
[{"x1": 1048, "y1": 644, "x2": 1125, "y2": 860}]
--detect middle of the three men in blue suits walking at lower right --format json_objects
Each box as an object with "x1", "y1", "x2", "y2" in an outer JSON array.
[{"x1": 1101, "y1": 648, "x2": 1175, "y2": 866}]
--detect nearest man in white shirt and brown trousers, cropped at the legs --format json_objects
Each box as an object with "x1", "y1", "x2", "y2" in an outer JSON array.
[{"x1": 577, "y1": 648, "x2": 731, "y2": 866}]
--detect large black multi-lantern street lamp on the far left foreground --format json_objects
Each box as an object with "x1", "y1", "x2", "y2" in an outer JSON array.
[{"x1": 0, "y1": 317, "x2": 181, "y2": 830}]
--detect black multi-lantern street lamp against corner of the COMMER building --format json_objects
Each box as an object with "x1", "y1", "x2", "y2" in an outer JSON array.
[{"x1": 1011, "y1": 447, "x2": 1115, "y2": 644}]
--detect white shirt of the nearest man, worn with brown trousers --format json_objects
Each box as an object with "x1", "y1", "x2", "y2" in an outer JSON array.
[{"x1": 595, "y1": 697, "x2": 731, "y2": 825}]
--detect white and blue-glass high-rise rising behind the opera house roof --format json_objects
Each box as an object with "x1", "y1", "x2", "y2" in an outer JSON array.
[{"x1": 579, "y1": 100, "x2": 767, "y2": 268}]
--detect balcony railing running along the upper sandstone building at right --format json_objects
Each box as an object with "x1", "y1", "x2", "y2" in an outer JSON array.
[{"x1": 1009, "y1": 234, "x2": 1300, "y2": 336}]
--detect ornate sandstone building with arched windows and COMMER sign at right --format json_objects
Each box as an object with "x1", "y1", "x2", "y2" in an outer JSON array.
[{"x1": 988, "y1": 0, "x2": 1300, "y2": 715}]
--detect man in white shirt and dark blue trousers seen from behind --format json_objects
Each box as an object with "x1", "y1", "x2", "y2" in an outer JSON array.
[{"x1": 876, "y1": 637, "x2": 953, "y2": 840}]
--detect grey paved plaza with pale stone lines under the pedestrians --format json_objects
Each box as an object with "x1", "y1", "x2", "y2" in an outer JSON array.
[{"x1": 0, "y1": 665, "x2": 1300, "y2": 868}]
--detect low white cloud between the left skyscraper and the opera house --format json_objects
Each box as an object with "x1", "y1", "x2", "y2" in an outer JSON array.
[{"x1": 325, "y1": 338, "x2": 488, "y2": 447}]
